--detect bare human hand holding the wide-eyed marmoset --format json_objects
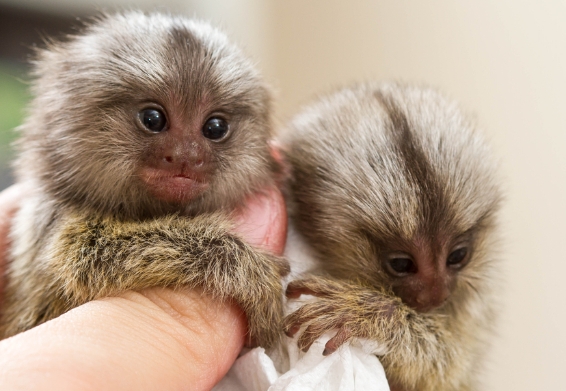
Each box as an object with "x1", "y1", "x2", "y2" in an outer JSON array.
[{"x1": 0, "y1": 186, "x2": 287, "y2": 391}]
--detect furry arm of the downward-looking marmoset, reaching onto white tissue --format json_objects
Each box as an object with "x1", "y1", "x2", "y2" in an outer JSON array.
[{"x1": 284, "y1": 277, "x2": 466, "y2": 390}]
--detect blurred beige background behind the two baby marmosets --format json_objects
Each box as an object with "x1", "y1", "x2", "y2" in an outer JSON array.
[{"x1": 0, "y1": 0, "x2": 566, "y2": 391}]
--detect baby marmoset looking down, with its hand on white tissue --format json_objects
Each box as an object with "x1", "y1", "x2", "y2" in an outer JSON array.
[{"x1": 282, "y1": 83, "x2": 500, "y2": 391}]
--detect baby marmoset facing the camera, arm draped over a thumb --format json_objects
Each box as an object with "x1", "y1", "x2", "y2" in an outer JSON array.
[{"x1": 0, "y1": 12, "x2": 288, "y2": 346}]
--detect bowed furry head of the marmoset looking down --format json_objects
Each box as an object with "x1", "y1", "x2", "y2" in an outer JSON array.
[{"x1": 283, "y1": 84, "x2": 499, "y2": 312}]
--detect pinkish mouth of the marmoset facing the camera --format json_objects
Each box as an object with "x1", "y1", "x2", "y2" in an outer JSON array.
[{"x1": 140, "y1": 168, "x2": 208, "y2": 204}]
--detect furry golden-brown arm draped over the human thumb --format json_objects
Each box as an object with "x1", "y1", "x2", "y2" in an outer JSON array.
[{"x1": 2, "y1": 214, "x2": 288, "y2": 346}]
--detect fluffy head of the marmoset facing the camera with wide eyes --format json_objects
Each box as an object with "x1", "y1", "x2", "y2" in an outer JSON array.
[{"x1": 17, "y1": 12, "x2": 275, "y2": 218}]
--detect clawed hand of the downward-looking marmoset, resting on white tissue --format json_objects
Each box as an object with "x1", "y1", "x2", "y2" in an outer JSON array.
[{"x1": 284, "y1": 278, "x2": 397, "y2": 355}]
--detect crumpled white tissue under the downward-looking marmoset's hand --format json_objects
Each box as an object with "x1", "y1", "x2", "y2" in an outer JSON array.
[{"x1": 213, "y1": 225, "x2": 389, "y2": 391}]
